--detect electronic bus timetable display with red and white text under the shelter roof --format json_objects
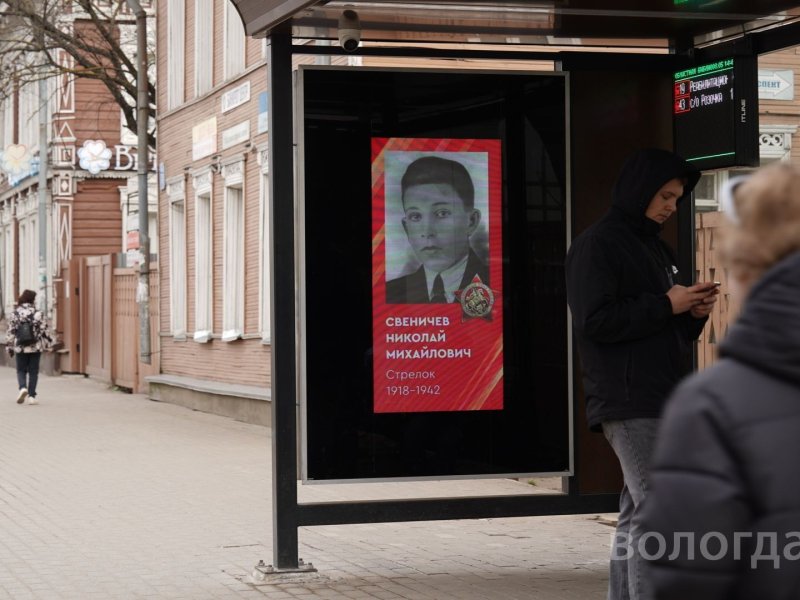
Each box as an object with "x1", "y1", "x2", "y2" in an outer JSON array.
[{"x1": 673, "y1": 57, "x2": 758, "y2": 170}]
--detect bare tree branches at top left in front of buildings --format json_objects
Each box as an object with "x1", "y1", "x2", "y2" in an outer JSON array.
[{"x1": 0, "y1": 0, "x2": 156, "y2": 147}]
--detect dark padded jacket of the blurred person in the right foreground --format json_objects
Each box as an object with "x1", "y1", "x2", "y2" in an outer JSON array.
[{"x1": 643, "y1": 253, "x2": 800, "y2": 600}]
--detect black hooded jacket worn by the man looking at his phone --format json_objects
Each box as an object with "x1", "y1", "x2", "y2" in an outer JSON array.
[{"x1": 566, "y1": 149, "x2": 706, "y2": 431}]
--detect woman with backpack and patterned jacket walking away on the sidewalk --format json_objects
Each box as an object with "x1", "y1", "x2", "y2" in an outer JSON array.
[{"x1": 6, "y1": 290, "x2": 53, "y2": 404}]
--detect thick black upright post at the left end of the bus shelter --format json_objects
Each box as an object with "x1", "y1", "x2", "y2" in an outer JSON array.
[{"x1": 267, "y1": 33, "x2": 299, "y2": 570}]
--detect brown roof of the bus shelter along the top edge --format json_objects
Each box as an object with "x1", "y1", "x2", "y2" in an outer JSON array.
[{"x1": 232, "y1": 0, "x2": 800, "y2": 53}]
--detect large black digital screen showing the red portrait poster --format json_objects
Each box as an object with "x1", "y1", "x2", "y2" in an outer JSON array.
[{"x1": 297, "y1": 66, "x2": 573, "y2": 483}]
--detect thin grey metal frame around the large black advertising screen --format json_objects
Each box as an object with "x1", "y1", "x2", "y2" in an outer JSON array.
[{"x1": 293, "y1": 65, "x2": 576, "y2": 485}]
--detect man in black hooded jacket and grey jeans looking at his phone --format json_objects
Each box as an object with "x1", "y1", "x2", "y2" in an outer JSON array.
[{"x1": 566, "y1": 149, "x2": 718, "y2": 600}]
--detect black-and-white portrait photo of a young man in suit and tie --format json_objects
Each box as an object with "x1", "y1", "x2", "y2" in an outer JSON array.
[{"x1": 385, "y1": 151, "x2": 489, "y2": 304}]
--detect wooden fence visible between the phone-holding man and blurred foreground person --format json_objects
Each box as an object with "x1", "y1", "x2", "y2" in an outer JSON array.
[{"x1": 695, "y1": 212, "x2": 740, "y2": 370}]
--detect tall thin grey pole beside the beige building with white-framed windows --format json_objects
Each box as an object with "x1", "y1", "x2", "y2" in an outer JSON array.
[{"x1": 127, "y1": 0, "x2": 150, "y2": 365}]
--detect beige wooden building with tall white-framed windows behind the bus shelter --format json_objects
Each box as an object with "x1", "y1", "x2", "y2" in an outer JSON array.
[{"x1": 155, "y1": 0, "x2": 800, "y2": 424}]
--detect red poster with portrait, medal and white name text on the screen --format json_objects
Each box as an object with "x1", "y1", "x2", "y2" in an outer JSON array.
[{"x1": 372, "y1": 138, "x2": 503, "y2": 413}]
